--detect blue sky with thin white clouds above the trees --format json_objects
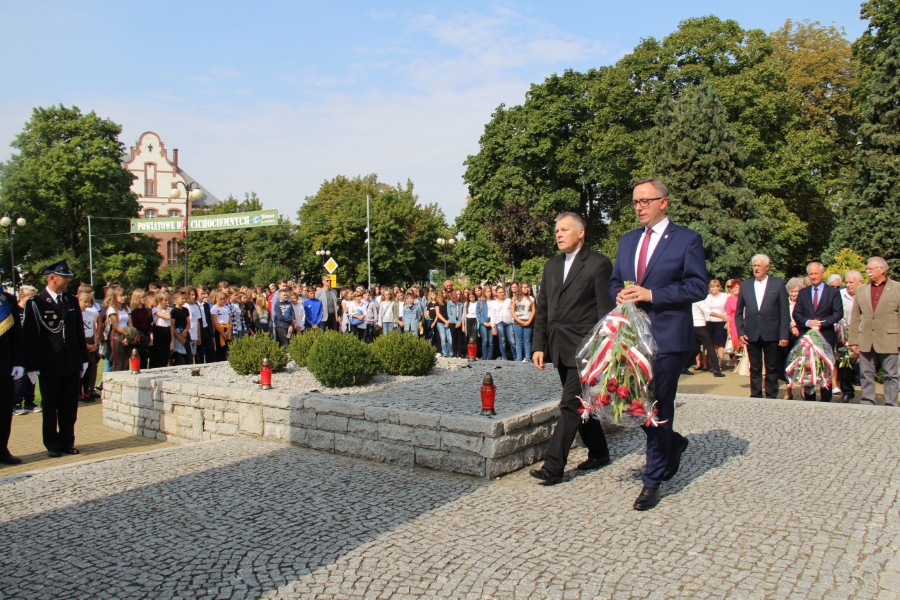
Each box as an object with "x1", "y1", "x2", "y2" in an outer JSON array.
[{"x1": 0, "y1": 0, "x2": 865, "y2": 220}]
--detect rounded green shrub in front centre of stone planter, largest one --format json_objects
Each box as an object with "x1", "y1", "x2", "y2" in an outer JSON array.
[{"x1": 306, "y1": 331, "x2": 379, "y2": 387}]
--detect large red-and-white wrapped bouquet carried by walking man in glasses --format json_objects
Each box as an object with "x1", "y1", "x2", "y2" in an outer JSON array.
[{"x1": 575, "y1": 302, "x2": 665, "y2": 427}]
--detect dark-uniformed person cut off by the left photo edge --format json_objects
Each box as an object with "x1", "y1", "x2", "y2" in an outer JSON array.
[{"x1": 0, "y1": 269, "x2": 25, "y2": 465}]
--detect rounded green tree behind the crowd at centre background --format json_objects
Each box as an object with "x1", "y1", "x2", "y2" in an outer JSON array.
[{"x1": 297, "y1": 174, "x2": 447, "y2": 285}]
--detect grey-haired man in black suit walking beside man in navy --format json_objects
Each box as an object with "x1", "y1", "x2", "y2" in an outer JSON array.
[{"x1": 531, "y1": 213, "x2": 613, "y2": 485}]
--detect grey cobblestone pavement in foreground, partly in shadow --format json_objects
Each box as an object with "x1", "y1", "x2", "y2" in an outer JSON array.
[{"x1": 0, "y1": 398, "x2": 900, "y2": 599}]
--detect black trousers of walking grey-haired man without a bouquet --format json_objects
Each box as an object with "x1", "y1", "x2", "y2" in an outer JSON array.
[{"x1": 544, "y1": 365, "x2": 609, "y2": 477}]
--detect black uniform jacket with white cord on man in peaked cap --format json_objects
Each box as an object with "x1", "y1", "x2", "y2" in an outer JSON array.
[{"x1": 22, "y1": 289, "x2": 88, "y2": 377}]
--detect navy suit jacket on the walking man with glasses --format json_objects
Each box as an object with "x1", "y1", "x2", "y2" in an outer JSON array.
[{"x1": 609, "y1": 221, "x2": 709, "y2": 354}]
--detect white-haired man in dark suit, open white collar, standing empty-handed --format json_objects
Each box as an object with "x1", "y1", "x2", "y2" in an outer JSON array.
[{"x1": 734, "y1": 254, "x2": 791, "y2": 398}]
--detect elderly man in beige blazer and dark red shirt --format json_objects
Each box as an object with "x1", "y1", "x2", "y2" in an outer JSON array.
[{"x1": 850, "y1": 256, "x2": 900, "y2": 406}]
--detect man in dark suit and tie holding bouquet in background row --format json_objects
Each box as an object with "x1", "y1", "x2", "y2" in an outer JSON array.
[{"x1": 794, "y1": 261, "x2": 844, "y2": 402}]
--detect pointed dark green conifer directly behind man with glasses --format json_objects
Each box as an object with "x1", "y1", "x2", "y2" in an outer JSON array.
[{"x1": 652, "y1": 82, "x2": 769, "y2": 279}]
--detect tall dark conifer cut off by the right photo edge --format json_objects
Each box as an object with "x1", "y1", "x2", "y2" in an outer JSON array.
[{"x1": 832, "y1": 37, "x2": 900, "y2": 273}]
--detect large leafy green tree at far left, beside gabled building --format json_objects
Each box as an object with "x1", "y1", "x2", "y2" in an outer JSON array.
[{"x1": 0, "y1": 105, "x2": 162, "y2": 284}]
